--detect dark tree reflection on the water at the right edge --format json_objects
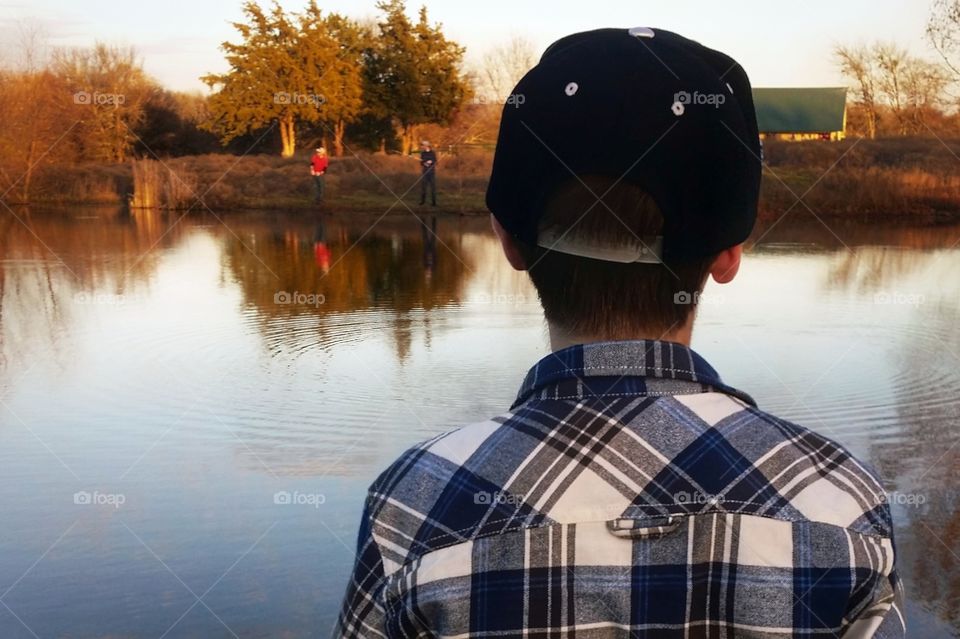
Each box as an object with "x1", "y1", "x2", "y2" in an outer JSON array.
[{"x1": 873, "y1": 294, "x2": 960, "y2": 628}]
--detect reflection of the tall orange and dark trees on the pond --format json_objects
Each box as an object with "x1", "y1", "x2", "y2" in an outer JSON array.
[{"x1": 224, "y1": 216, "x2": 478, "y2": 361}]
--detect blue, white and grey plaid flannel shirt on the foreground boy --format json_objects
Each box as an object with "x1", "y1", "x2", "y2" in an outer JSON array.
[{"x1": 335, "y1": 341, "x2": 905, "y2": 639}]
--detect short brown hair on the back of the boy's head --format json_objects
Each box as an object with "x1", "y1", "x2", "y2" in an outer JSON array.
[{"x1": 518, "y1": 176, "x2": 715, "y2": 339}]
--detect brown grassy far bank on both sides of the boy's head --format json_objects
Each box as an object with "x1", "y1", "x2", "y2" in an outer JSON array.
[{"x1": 13, "y1": 138, "x2": 960, "y2": 218}]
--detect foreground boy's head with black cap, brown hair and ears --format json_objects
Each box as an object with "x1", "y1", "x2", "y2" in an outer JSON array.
[{"x1": 487, "y1": 28, "x2": 760, "y2": 338}]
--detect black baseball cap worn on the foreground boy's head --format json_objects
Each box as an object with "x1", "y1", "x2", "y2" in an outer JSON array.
[{"x1": 486, "y1": 27, "x2": 761, "y2": 262}]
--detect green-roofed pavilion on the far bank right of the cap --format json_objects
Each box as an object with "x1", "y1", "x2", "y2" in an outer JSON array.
[{"x1": 753, "y1": 87, "x2": 847, "y2": 140}]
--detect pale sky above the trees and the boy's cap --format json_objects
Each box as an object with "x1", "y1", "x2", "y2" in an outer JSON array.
[{"x1": 0, "y1": 0, "x2": 935, "y2": 90}]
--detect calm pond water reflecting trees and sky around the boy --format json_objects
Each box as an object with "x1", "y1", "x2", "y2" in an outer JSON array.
[{"x1": 0, "y1": 209, "x2": 960, "y2": 639}]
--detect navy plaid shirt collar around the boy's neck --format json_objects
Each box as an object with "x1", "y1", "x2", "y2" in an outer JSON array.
[{"x1": 511, "y1": 340, "x2": 756, "y2": 409}]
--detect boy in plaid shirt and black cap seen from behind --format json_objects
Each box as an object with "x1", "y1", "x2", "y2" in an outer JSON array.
[{"x1": 336, "y1": 28, "x2": 905, "y2": 639}]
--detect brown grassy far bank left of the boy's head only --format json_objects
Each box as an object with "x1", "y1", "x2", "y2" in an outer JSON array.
[{"x1": 18, "y1": 151, "x2": 491, "y2": 213}]
